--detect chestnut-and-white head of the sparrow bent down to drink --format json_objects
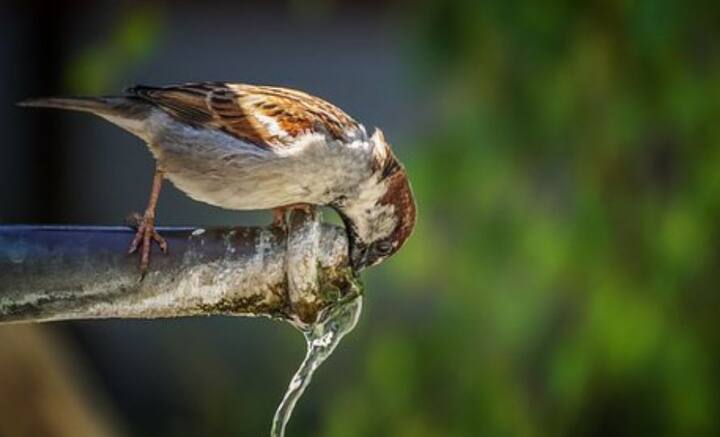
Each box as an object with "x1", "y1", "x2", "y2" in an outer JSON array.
[{"x1": 335, "y1": 129, "x2": 415, "y2": 272}]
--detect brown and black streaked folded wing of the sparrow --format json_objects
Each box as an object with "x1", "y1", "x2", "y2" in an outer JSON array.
[{"x1": 126, "y1": 82, "x2": 362, "y2": 149}]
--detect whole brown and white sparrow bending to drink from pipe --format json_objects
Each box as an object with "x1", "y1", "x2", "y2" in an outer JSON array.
[{"x1": 18, "y1": 82, "x2": 416, "y2": 278}]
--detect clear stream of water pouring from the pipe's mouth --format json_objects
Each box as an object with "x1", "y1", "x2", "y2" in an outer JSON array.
[{"x1": 270, "y1": 296, "x2": 362, "y2": 437}]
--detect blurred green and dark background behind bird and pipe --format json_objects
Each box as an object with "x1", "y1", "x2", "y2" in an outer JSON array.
[{"x1": 0, "y1": 0, "x2": 720, "y2": 437}]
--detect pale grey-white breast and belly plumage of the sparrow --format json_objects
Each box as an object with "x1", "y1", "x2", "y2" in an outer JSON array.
[{"x1": 137, "y1": 113, "x2": 380, "y2": 210}]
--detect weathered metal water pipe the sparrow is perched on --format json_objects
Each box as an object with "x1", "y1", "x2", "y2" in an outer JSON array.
[{"x1": 0, "y1": 211, "x2": 361, "y2": 329}]
